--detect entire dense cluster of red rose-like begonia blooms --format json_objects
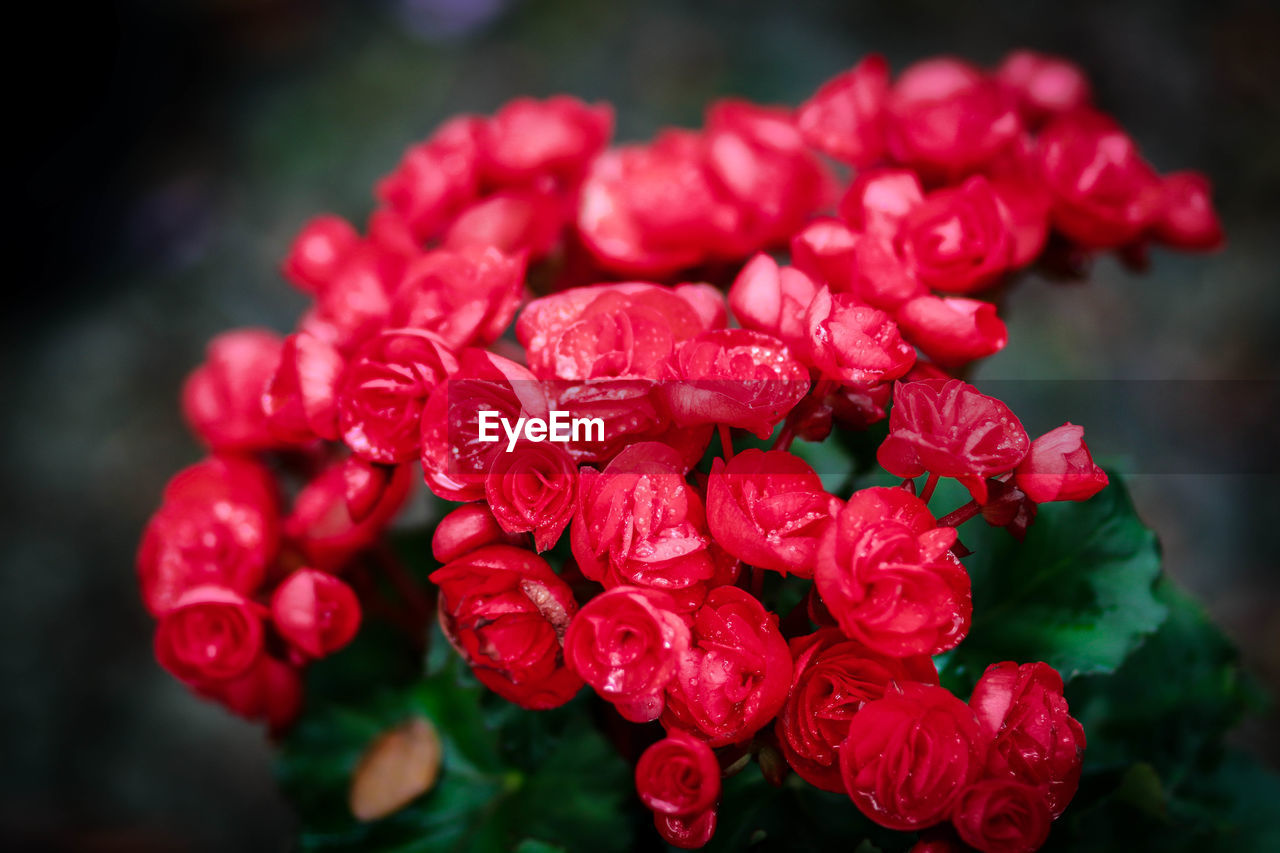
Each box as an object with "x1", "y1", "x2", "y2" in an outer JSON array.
[{"x1": 138, "y1": 53, "x2": 1221, "y2": 850}]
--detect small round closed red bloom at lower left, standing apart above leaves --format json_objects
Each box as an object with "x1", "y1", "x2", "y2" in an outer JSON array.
[{"x1": 271, "y1": 569, "x2": 360, "y2": 657}]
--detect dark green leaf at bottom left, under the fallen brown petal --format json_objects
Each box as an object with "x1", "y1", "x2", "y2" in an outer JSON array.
[{"x1": 278, "y1": 635, "x2": 631, "y2": 853}]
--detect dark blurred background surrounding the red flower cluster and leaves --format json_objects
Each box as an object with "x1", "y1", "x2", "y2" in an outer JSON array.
[{"x1": 0, "y1": 0, "x2": 1280, "y2": 850}]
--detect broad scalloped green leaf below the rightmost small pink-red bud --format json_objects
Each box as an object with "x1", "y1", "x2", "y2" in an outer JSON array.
[{"x1": 947, "y1": 475, "x2": 1165, "y2": 695}]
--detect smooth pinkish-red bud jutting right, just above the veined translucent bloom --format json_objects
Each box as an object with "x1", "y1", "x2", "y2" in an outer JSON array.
[{"x1": 893, "y1": 295, "x2": 1009, "y2": 368}]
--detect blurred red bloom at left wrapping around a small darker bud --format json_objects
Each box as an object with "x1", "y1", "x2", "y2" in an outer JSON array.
[{"x1": 284, "y1": 450, "x2": 415, "y2": 571}]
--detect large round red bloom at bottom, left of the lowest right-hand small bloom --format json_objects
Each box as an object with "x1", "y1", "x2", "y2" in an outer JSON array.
[{"x1": 840, "y1": 684, "x2": 987, "y2": 830}]
